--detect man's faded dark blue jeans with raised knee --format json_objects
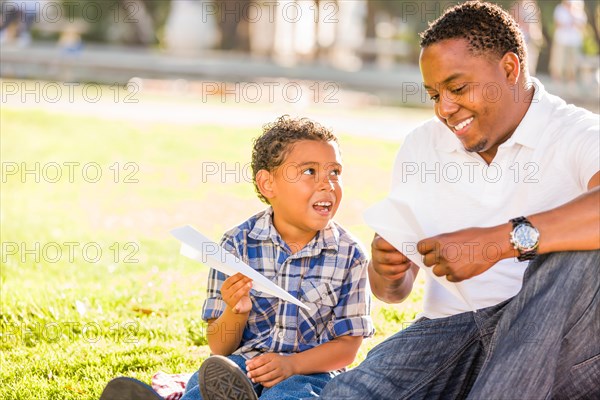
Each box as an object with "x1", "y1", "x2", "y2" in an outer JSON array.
[{"x1": 321, "y1": 251, "x2": 600, "y2": 400}]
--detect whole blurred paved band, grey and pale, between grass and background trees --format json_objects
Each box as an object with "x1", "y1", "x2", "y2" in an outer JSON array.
[{"x1": 0, "y1": 43, "x2": 600, "y2": 141}]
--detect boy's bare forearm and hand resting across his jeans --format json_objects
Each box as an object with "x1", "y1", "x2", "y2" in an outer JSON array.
[{"x1": 246, "y1": 336, "x2": 363, "y2": 387}]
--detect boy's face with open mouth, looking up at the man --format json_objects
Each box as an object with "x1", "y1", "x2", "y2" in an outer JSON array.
[{"x1": 267, "y1": 140, "x2": 342, "y2": 247}]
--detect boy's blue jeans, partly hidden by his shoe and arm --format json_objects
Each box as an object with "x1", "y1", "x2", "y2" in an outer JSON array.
[{"x1": 181, "y1": 355, "x2": 333, "y2": 400}]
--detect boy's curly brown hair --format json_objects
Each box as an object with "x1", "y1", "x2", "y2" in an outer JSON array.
[{"x1": 252, "y1": 115, "x2": 338, "y2": 204}]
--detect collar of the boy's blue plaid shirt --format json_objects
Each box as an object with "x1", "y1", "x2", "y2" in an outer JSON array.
[{"x1": 248, "y1": 207, "x2": 340, "y2": 257}]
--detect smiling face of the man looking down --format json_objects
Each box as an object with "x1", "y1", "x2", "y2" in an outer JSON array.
[{"x1": 420, "y1": 39, "x2": 524, "y2": 162}]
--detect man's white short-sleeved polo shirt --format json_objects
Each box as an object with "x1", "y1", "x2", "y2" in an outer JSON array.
[{"x1": 390, "y1": 79, "x2": 600, "y2": 318}]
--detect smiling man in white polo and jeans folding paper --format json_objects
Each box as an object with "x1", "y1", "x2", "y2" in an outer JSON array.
[{"x1": 321, "y1": 1, "x2": 600, "y2": 400}]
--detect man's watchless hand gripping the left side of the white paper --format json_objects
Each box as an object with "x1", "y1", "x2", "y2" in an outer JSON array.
[{"x1": 371, "y1": 235, "x2": 413, "y2": 281}]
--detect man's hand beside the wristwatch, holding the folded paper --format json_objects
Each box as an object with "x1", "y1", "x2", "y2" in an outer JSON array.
[{"x1": 417, "y1": 224, "x2": 514, "y2": 282}]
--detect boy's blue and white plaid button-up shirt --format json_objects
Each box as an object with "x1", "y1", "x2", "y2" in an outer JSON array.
[{"x1": 202, "y1": 207, "x2": 374, "y2": 359}]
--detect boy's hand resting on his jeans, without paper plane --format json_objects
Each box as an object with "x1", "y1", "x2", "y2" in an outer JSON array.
[{"x1": 246, "y1": 353, "x2": 294, "y2": 387}]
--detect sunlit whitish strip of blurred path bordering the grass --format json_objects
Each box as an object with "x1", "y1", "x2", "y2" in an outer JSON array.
[{"x1": 0, "y1": 74, "x2": 433, "y2": 142}]
